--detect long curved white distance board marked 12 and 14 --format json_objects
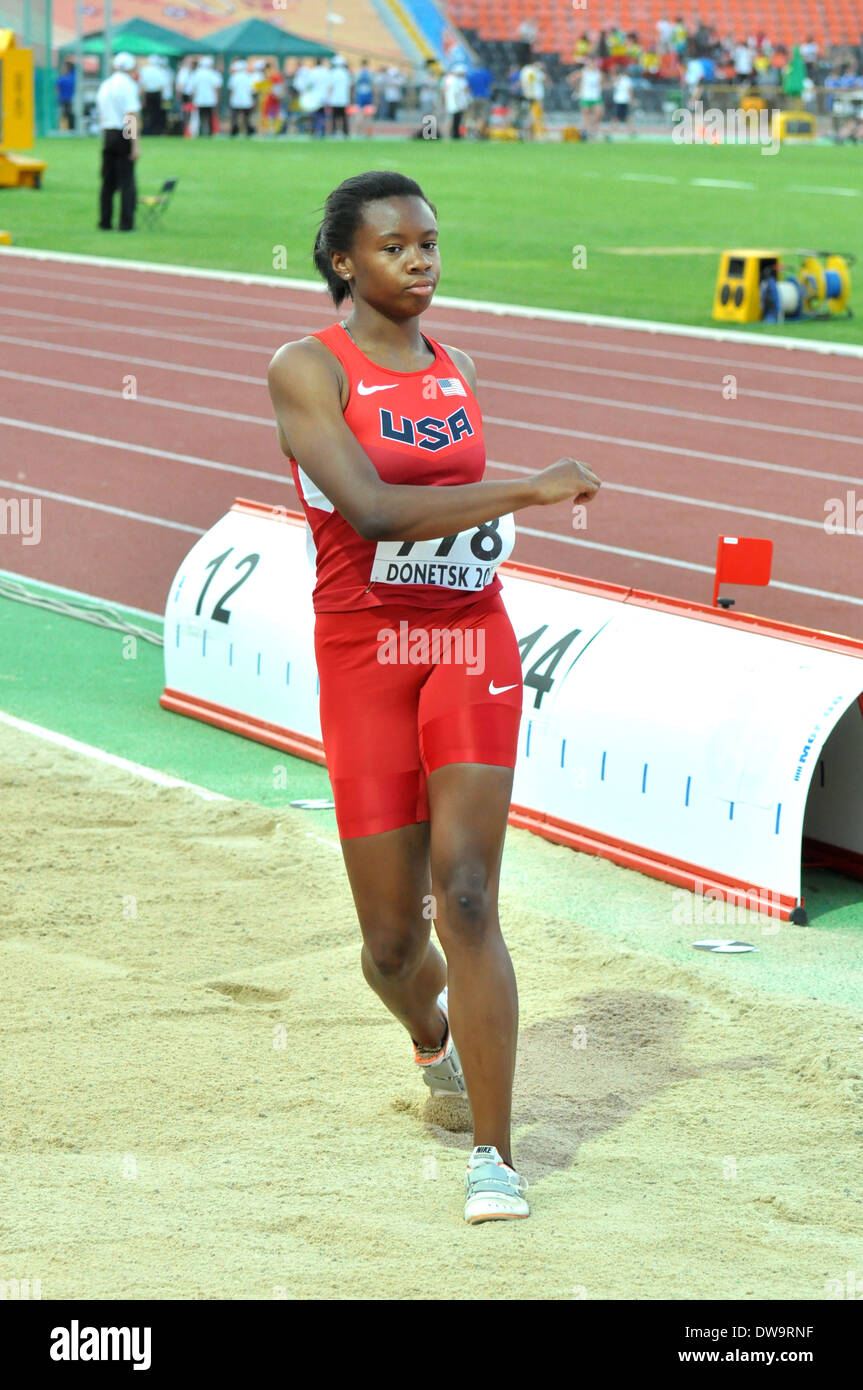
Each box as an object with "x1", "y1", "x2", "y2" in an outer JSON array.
[{"x1": 161, "y1": 500, "x2": 863, "y2": 920}]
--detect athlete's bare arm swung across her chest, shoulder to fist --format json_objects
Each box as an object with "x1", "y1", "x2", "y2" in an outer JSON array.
[{"x1": 267, "y1": 338, "x2": 599, "y2": 541}]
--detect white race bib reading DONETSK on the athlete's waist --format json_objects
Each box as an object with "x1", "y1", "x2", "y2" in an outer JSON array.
[{"x1": 368, "y1": 512, "x2": 516, "y2": 592}]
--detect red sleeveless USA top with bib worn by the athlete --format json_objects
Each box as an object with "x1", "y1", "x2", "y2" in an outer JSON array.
[{"x1": 290, "y1": 322, "x2": 516, "y2": 613}]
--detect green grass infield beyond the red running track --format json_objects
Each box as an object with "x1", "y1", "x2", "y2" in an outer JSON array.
[{"x1": 0, "y1": 138, "x2": 863, "y2": 343}]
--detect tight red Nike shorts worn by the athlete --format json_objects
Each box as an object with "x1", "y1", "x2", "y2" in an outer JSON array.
[{"x1": 314, "y1": 594, "x2": 521, "y2": 840}]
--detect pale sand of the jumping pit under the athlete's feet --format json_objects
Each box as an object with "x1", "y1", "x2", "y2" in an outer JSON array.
[{"x1": 0, "y1": 726, "x2": 863, "y2": 1300}]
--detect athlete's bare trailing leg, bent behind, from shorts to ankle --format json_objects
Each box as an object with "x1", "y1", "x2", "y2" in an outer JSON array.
[{"x1": 342, "y1": 820, "x2": 454, "y2": 1047}]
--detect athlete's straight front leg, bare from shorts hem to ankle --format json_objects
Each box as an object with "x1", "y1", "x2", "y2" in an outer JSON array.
[{"x1": 428, "y1": 763, "x2": 518, "y2": 1165}]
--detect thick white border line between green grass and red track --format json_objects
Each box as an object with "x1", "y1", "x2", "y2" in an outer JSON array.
[{"x1": 0, "y1": 247, "x2": 863, "y2": 357}]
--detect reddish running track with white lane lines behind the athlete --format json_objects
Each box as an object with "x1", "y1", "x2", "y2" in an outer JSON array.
[{"x1": 0, "y1": 253, "x2": 863, "y2": 637}]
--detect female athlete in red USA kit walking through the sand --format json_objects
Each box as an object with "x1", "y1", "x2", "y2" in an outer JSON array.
[{"x1": 268, "y1": 171, "x2": 600, "y2": 1223}]
